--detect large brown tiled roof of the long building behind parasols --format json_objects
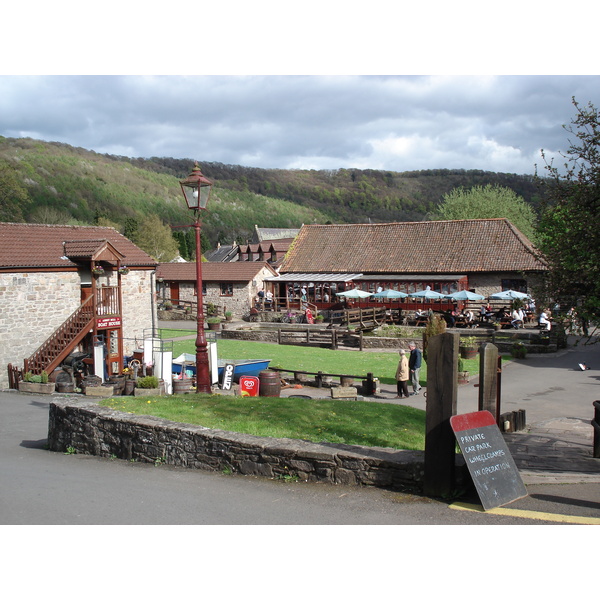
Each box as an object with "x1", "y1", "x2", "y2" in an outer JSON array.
[{"x1": 280, "y1": 219, "x2": 547, "y2": 274}]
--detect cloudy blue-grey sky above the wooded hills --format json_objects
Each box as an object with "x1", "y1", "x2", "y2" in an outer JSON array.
[{"x1": 0, "y1": 75, "x2": 600, "y2": 173}]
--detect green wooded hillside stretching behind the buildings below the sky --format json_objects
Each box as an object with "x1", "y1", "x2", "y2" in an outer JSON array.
[{"x1": 0, "y1": 137, "x2": 540, "y2": 246}]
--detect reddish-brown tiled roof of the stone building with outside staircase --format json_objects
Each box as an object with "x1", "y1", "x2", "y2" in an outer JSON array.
[{"x1": 0, "y1": 223, "x2": 156, "y2": 269}]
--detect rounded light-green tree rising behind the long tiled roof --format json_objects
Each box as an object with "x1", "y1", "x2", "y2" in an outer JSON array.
[{"x1": 438, "y1": 184, "x2": 537, "y2": 241}]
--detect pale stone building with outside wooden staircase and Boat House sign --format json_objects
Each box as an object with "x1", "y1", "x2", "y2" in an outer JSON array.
[{"x1": 0, "y1": 223, "x2": 157, "y2": 389}]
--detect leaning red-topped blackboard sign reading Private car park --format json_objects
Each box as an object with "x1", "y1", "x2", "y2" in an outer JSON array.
[{"x1": 450, "y1": 410, "x2": 527, "y2": 510}]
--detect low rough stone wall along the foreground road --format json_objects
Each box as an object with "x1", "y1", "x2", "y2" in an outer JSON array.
[{"x1": 48, "y1": 400, "x2": 452, "y2": 489}]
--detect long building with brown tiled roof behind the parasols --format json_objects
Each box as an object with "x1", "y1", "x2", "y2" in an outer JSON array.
[{"x1": 270, "y1": 219, "x2": 547, "y2": 309}]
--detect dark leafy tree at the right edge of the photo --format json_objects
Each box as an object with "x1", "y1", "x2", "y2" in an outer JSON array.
[{"x1": 538, "y1": 98, "x2": 600, "y2": 328}]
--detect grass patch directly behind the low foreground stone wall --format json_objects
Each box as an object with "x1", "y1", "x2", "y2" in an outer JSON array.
[{"x1": 100, "y1": 394, "x2": 425, "y2": 450}]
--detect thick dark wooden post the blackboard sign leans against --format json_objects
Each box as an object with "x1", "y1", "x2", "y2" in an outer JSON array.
[{"x1": 423, "y1": 333, "x2": 460, "y2": 497}]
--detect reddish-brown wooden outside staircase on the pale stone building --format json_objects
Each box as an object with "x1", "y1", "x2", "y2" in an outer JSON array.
[{"x1": 24, "y1": 296, "x2": 95, "y2": 375}]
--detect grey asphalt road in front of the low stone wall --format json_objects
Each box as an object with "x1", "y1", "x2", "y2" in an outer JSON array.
[{"x1": 0, "y1": 392, "x2": 600, "y2": 525}]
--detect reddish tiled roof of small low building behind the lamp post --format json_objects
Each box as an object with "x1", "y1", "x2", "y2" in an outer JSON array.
[{"x1": 156, "y1": 261, "x2": 275, "y2": 282}]
